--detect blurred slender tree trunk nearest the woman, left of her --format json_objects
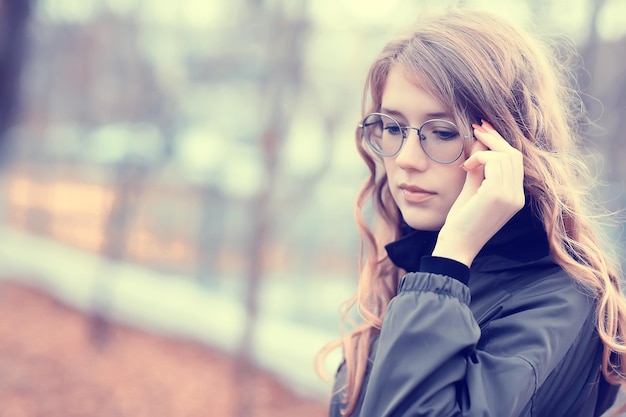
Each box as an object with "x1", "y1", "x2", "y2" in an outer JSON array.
[{"x1": 235, "y1": 0, "x2": 307, "y2": 417}]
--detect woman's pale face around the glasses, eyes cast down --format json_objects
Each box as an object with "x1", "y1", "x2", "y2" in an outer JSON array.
[{"x1": 380, "y1": 65, "x2": 466, "y2": 230}]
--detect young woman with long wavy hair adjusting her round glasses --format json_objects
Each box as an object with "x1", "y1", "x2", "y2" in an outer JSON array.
[{"x1": 318, "y1": 7, "x2": 626, "y2": 417}]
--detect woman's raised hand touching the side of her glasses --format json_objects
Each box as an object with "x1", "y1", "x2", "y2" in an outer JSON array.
[{"x1": 433, "y1": 120, "x2": 524, "y2": 266}]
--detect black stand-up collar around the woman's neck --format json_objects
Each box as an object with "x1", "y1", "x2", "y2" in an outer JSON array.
[{"x1": 385, "y1": 195, "x2": 549, "y2": 272}]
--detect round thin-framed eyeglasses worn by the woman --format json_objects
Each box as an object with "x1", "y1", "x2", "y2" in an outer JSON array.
[{"x1": 359, "y1": 113, "x2": 464, "y2": 164}]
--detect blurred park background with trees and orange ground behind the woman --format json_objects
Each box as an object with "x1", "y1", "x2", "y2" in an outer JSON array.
[{"x1": 0, "y1": 0, "x2": 626, "y2": 417}]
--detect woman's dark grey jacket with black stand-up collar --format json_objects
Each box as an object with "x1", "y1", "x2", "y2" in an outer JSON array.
[{"x1": 330, "y1": 205, "x2": 617, "y2": 417}]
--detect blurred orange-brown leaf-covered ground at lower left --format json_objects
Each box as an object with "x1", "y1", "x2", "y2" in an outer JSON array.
[{"x1": 0, "y1": 281, "x2": 327, "y2": 417}]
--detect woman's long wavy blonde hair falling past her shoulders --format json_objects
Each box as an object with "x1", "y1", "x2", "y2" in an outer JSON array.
[{"x1": 316, "y1": 10, "x2": 626, "y2": 415}]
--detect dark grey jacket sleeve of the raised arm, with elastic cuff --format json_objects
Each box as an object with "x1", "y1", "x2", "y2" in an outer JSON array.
[{"x1": 360, "y1": 258, "x2": 591, "y2": 417}]
